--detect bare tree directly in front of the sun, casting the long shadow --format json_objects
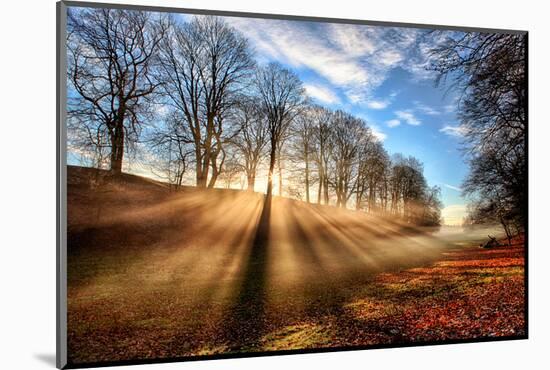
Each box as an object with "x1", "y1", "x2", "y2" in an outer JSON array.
[{"x1": 255, "y1": 63, "x2": 305, "y2": 197}]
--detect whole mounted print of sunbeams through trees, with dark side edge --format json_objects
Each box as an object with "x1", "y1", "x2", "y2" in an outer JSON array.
[{"x1": 57, "y1": 2, "x2": 528, "y2": 368}]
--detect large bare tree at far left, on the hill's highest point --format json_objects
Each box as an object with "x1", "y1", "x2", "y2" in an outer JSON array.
[{"x1": 67, "y1": 8, "x2": 166, "y2": 174}]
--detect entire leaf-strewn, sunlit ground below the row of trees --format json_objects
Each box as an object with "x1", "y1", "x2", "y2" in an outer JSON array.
[{"x1": 67, "y1": 167, "x2": 525, "y2": 364}]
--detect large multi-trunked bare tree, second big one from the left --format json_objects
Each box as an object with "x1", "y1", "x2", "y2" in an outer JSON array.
[{"x1": 159, "y1": 16, "x2": 254, "y2": 187}]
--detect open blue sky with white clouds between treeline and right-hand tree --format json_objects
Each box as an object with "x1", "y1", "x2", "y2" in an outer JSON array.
[{"x1": 213, "y1": 17, "x2": 468, "y2": 224}]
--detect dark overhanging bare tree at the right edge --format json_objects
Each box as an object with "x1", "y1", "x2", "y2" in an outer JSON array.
[{"x1": 432, "y1": 32, "x2": 527, "y2": 232}]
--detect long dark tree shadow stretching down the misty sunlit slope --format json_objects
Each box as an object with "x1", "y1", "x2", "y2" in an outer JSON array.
[{"x1": 224, "y1": 196, "x2": 272, "y2": 351}]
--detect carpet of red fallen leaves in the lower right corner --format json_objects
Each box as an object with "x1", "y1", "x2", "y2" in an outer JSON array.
[{"x1": 344, "y1": 246, "x2": 525, "y2": 344}]
